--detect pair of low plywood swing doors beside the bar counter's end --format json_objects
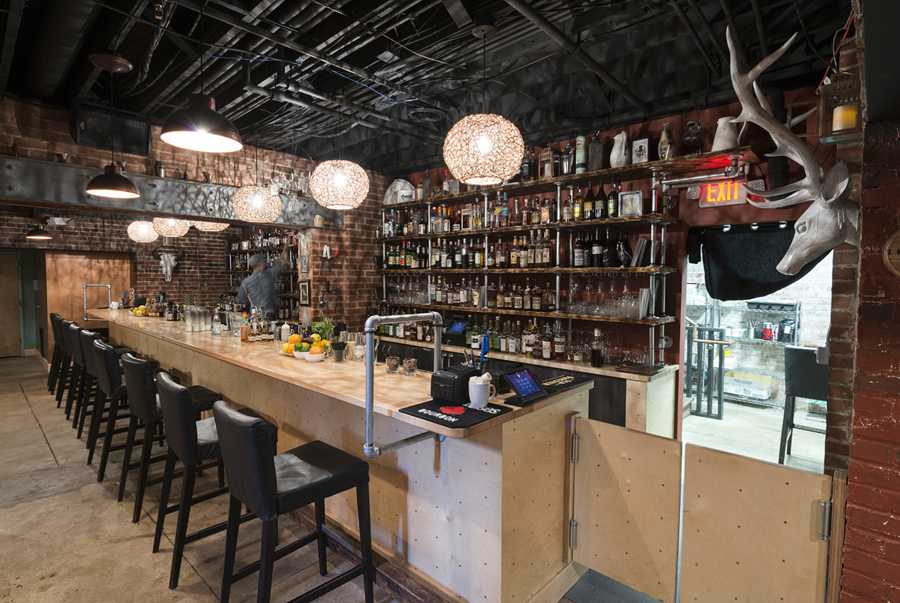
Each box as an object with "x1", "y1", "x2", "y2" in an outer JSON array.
[{"x1": 573, "y1": 419, "x2": 832, "y2": 603}]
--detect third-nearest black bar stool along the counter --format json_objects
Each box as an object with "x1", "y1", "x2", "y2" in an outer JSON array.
[{"x1": 118, "y1": 353, "x2": 224, "y2": 523}]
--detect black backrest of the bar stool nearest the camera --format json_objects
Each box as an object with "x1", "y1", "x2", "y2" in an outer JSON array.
[{"x1": 213, "y1": 400, "x2": 278, "y2": 521}]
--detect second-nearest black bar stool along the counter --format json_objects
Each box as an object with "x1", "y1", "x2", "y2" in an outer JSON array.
[{"x1": 153, "y1": 372, "x2": 278, "y2": 589}]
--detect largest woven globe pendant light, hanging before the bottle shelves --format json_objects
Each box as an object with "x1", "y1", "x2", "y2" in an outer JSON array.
[{"x1": 444, "y1": 25, "x2": 525, "y2": 186}]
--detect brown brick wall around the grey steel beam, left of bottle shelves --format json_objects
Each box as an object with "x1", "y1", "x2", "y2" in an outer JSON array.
[{"x1": 0, "y1": 97, "x2": 390, "y2": 329}]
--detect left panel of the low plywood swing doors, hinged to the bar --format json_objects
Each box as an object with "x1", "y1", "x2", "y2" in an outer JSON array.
[{"x1": 573, "y1": 419, "x2": 681, "y2": 603}]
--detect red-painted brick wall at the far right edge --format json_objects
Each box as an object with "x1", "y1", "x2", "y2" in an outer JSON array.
[{"x1": 841, "y1": 123, "x2": 900, "y2": 602}]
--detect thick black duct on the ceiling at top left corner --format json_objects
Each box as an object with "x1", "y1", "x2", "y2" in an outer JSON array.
[{"x1": 26, "y1": 0, "x2": 101, "y2": 98}]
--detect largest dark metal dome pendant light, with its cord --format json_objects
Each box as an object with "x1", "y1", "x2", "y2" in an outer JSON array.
[{"x1": 160, "y1": 0, "x2": 244, "y2": 153}]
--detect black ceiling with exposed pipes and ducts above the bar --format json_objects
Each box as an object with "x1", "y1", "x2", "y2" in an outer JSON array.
[{"x1": 0, "y1": 0, "x2": 850, "y2": 174}]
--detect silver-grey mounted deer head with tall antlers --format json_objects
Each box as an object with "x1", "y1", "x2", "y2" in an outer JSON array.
[{"x1": 727, "y1": 28, "x2": 859, "y2": 274}]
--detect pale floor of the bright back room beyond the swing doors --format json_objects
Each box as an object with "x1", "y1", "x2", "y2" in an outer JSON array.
[{"x1": 682, "y1": 398, "x2": 825, "y2": 473}]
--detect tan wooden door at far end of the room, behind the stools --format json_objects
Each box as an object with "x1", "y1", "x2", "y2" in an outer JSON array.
[{"x1": 46, "y1": 251, "x2": 133, "y2": 349}]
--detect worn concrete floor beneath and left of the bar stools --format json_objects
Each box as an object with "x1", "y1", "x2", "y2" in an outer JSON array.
[{"x1": 0, "y1": 358, "x2": 392, "y2": 603}]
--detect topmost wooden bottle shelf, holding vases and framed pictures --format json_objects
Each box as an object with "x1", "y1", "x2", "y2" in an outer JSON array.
[{"x1": 384, "y1": 147, "x2": 759, "y2": 210}]
